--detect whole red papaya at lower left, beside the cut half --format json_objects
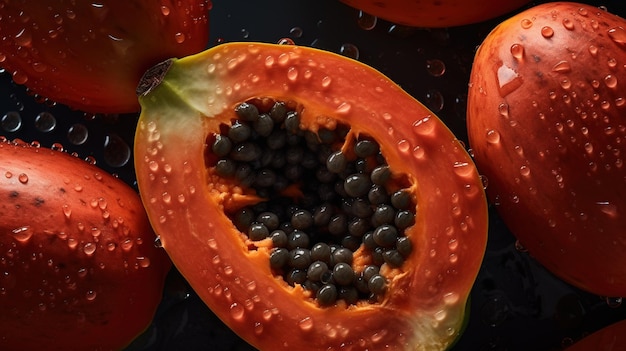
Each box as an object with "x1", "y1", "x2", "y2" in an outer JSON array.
[{"x1": 0, "y1": 140, "x2": 171, "y2": 351}]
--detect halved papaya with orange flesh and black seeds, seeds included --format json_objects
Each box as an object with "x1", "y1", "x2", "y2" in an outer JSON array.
[{"x1": 135, "y1": 43, "x2": 487, "y2": 350}]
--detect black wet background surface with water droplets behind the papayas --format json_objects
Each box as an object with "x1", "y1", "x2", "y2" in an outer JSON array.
[{"x1": 0, "y1": 0, "x2": 626, "y2": 351}]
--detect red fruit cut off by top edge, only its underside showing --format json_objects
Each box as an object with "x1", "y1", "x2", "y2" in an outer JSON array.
[{"x1": 341, "y1": 0, "x2": 529, "y2": 28}]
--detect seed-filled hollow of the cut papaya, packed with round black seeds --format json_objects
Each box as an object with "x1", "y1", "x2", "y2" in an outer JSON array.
[{"x1": 205, "y1": 99, "x2": 417, "y2": 306}]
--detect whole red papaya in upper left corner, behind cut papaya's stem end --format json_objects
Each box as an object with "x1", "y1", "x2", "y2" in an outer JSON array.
[{"x1": 0, "y1": 0, "x2": 209, "y2": 113}]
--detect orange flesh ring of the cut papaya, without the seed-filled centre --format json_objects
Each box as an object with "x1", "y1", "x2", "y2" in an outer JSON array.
[{"x1": 135, "y1": 43, "x2": 487, "y2": 350}]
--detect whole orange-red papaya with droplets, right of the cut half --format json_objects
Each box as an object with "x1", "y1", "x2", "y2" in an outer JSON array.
[{"x1": 467, "y1": 2, "x2": 626, "y2": 296}]
